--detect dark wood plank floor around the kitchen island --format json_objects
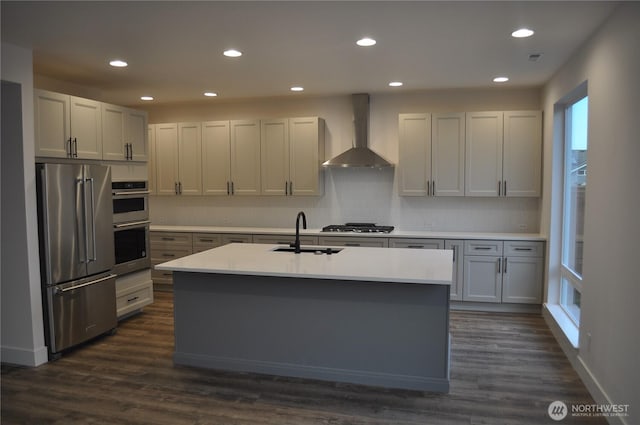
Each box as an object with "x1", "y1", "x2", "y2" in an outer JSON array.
[{"x1": 1, "y1": 292, "x2": 606, "y2": 425}]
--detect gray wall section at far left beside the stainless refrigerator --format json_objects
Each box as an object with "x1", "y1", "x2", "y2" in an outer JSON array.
[{"x1": 0, "y1": 43, "x2": 47, "y2": 366}]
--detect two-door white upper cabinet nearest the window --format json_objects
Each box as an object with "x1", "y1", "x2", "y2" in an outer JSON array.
[{"x1": 466, "y1": 111, "x2": 542, "y2": 197}]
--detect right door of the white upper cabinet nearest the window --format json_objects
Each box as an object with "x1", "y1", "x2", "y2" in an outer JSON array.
[{"x1": 502, "y1": 111, "x2": 542, "y2": 197}]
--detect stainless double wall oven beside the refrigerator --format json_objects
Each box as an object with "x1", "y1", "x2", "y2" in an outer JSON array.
[{"x1": 111, "y1": 181, "x2": 151, "y2": 276}]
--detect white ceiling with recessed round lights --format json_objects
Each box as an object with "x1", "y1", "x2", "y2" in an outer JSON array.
[{"x1": 1, "y1": 1, "x2": 616, "y2": 105}]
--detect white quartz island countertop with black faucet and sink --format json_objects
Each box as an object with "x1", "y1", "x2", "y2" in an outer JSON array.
[{"x1": 156, "y1": 243, "x2": 453, "y2": 285}]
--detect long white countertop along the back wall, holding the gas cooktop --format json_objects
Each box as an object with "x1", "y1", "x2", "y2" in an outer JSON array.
[{"x1": 150, "y1": 224, "x2": 547, "y2": 241}]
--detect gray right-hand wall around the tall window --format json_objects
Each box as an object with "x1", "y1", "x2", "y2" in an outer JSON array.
[{"x1": 541, "y1": 2, "x2": 640, "y2": 414}]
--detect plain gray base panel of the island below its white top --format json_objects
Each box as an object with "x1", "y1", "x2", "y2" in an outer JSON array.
[{"x1": 167, "y1": 270, "x2": 449, "y2": 392}]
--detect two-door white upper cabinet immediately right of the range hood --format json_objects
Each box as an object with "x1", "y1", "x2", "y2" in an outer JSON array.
[{"x1": 398, "y1": 113, "x2": 465, "y2": 196}]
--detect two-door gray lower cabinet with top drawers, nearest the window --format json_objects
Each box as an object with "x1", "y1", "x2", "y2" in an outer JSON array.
[{"x1": 462, "y1": 240, "x2": 544, "y2": 304}]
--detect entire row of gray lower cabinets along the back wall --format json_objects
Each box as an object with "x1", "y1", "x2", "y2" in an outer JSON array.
[{"x1": 151, "y1": 231, "x2": 544, "y2": 304}]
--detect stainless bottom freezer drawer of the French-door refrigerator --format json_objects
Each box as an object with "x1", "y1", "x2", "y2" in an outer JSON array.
[{"x1": 47, "y1": 274, "x2": 118, "y2": 353}]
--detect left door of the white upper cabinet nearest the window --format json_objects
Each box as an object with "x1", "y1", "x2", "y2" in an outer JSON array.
[{"x1": 465, "y1": 112, "x2": 503, "y2": 196}]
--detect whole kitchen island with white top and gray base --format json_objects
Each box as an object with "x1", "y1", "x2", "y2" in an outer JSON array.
[{"x1": 156, "y1": 244, "x2": 453, "y2": 392}]
